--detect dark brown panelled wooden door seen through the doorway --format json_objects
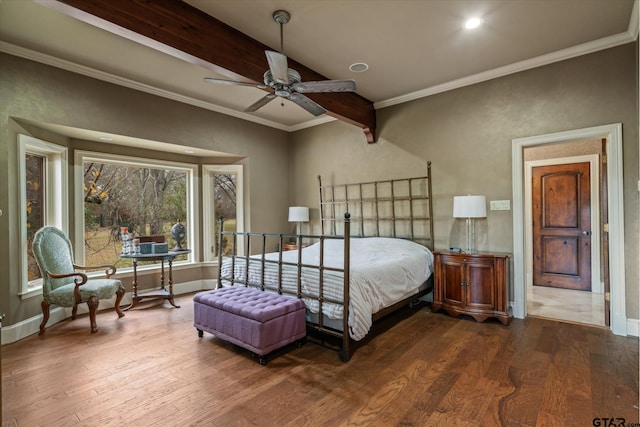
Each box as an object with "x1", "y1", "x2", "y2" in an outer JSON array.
[{"x1": 532, "y1": 162, "x2": 591, "y2": 291}]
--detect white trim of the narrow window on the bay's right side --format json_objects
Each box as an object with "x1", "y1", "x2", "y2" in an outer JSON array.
[{"x1": 202, "y1": 165, "x2": 244, "y2": 264}]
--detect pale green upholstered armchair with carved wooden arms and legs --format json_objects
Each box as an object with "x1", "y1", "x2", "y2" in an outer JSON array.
[{"x1": 32, "y1": 226, "x2": 124, "y2": 335}]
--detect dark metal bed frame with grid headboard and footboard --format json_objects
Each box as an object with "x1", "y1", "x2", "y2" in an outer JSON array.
[{"x1": 217, "y1": 162, "x2": 434, "y2": 362}]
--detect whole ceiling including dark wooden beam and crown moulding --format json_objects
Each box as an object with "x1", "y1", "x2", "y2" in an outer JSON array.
[{"x1": 0, "y1": 0, "x2": 638, "y2": 142}]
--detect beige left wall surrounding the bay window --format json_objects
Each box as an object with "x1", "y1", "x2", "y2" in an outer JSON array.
[{"x1": 0, "y1": 54, "x2": 289, "y2": 326}]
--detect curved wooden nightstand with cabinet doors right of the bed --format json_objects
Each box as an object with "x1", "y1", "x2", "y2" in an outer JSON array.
[{"x1": 431, "y1": 251, "x2": 511, "y2": 325}]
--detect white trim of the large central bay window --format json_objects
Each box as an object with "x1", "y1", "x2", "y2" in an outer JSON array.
[{"x1": 73, "y1": 150, "x2": 200, "y2": 271}]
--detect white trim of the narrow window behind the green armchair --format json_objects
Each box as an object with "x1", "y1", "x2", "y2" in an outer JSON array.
[{"x1": 18, "y1": 134, "x2": 69, "y2": 299}]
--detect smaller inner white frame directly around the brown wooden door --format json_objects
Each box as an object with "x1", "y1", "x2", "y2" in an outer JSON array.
[{"x1": 524, "y1": 154, "x2": 604, "y2": 294}]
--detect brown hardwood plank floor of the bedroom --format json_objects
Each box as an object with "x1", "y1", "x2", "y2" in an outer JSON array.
[{"x1": 1, "y1": 295, "x2": 639, "y2": 427}]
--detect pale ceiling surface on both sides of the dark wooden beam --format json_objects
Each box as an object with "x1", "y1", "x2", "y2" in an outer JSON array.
[{"x1": 0, "y1": 0, "x2": 638, "y2": 135}]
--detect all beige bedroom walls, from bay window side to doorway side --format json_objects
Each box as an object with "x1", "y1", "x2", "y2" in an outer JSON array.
[{"x1": 0, "y1": 40, "x2": 640, "y2": 326}]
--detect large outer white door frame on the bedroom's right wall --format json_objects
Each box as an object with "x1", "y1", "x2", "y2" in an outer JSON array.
[{"x1": 511, "y1": 123, "x2": 627, "y2": 336}]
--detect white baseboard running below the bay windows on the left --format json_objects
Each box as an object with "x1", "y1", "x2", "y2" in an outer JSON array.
[{"x1": 1, "y1": 279, "x2": 217, "y2": 345}]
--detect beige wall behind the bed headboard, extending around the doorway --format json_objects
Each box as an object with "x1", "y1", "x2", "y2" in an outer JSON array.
[{"x1": 291, "y1": 44, "x2": 640, "y2": 319}]
